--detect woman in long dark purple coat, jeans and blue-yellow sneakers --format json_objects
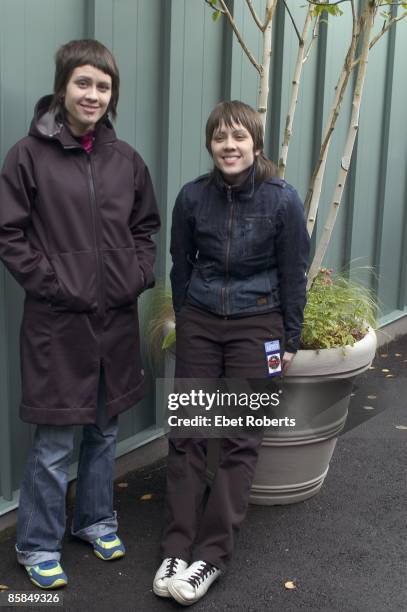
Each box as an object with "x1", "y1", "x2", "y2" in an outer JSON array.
[{"x1": 0, "y1": 40, "x2": 159, "y2": 588}]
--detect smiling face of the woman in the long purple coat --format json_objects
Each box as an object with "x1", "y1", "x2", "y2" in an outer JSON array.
[{"x1": 64, "y1": 64, "x2": 112, "y2": 136}]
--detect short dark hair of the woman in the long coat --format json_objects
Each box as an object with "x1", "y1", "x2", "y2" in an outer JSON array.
[{"x1": 51, "y1": 38, "x2": 120, "y2": 119}]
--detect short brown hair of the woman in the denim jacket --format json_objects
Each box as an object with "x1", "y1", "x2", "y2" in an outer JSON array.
[{"x1": 205, "y1": 100, "x2": 276, "y2": 181}]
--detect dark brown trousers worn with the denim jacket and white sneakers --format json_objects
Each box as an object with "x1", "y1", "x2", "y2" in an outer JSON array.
[{"x1": 162, "y1": 304, "x2": 284, "y2": 570}]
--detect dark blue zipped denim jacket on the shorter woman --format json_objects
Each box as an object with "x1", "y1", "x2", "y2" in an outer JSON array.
[{"x1": 171, "y1": 168, "x2": 309, "y2": 352}]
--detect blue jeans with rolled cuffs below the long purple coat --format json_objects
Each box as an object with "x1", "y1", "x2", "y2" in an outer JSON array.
[{"x1": 16, "y1": 384, "x2": 118, "y2": 565}]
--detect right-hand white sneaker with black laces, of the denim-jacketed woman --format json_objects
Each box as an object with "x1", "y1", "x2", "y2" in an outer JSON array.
[{"x1": 168, "y1": 561, "x2": 221, "y2": 606}]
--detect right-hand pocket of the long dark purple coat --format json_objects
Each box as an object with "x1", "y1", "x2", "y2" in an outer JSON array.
[{"x1": 103, "y1": 247, "x2": 145, "y2": 308}]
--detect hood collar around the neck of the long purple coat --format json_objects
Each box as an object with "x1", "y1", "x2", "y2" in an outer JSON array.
[{"x1": 29, "y1": 95, "x2": 116, "y2": 149}]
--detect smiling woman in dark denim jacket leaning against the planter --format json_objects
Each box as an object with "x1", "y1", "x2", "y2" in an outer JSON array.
[{"x1": 153, "y1": 101, "x2": 309, "y2": 605}]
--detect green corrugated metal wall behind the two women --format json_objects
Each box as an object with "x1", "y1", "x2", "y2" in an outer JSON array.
[{"x1": 0, "y1": 0, "x2": 407, "y2": 512}]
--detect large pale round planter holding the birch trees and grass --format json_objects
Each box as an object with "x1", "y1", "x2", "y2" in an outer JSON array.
[{"x1": 250, "y1": 329, "x2": 377, "y2": 505}]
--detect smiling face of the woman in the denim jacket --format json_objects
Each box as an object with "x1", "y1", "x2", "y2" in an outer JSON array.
[{"x1": 211, "y1": 123, "x2": 260, "y2": 185}]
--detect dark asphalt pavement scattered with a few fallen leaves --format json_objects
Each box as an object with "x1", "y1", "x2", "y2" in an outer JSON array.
[{"x1": 0, "y1": 336, "x2": 407, "y2": 612}]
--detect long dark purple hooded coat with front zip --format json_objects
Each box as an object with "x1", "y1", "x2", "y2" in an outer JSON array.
[{"x1": 0, "y1": 96, "x2": 159, "y2": 425}]
